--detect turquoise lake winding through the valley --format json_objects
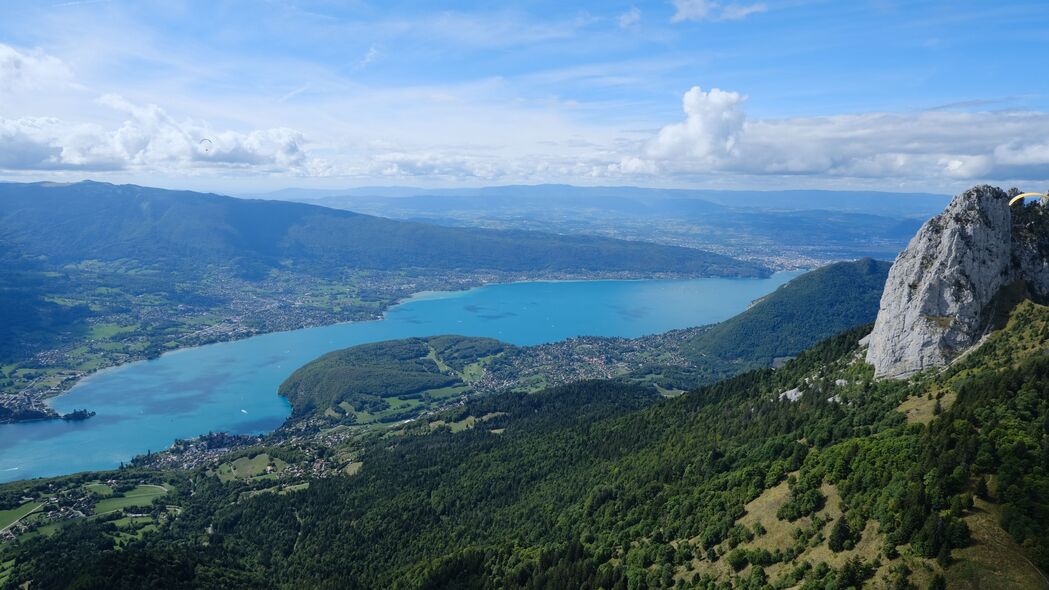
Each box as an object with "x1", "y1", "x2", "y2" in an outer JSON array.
[{"x1": 0, "y1": 272, "x2": 799, "y2": 481}]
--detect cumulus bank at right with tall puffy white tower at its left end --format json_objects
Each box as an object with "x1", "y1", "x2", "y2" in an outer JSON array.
[{"x1": 625, "y1": 81, "x2": 1049, "y2": 180}]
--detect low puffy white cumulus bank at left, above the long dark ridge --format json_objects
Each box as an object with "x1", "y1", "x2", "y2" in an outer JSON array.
[{"x1": 0, "y1": 94, "x2": 306, "y2": 172}]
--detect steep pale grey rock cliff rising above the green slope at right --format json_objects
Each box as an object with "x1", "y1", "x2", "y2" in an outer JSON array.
[{"x1": 866, "y1": 186, "x2": 1049, "y2": 377}]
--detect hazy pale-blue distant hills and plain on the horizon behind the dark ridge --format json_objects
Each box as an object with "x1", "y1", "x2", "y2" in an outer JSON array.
[{"x1": 253, "y1": 185, "x2": 949, "y2": 268}]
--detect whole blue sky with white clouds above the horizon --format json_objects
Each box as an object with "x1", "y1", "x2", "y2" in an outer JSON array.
[{"x1": 0, "y1": 0, "x2": 1049, "y2": 193}]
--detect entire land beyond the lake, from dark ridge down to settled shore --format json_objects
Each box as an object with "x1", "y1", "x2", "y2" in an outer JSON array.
[{"x1": 0, "y1": 183, "x2": 770, "y2": 422}]
